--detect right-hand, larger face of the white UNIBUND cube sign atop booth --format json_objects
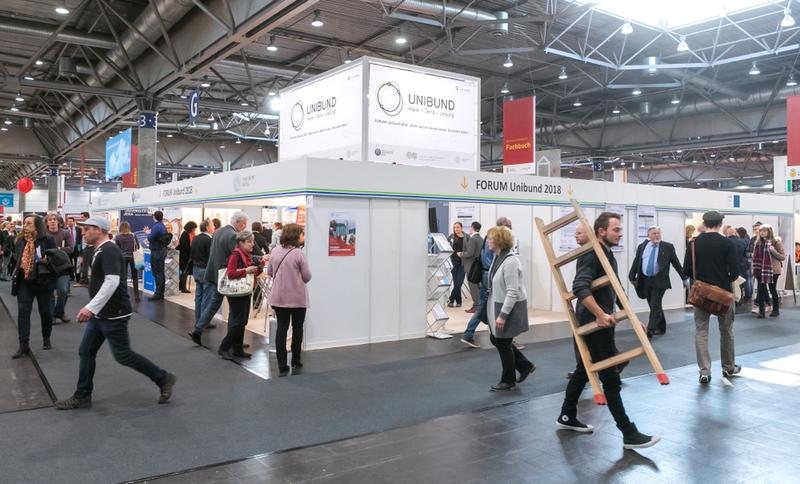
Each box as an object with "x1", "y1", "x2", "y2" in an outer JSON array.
[{"x1": 367, "y1": 63, "x2": 480, "y2": 170}]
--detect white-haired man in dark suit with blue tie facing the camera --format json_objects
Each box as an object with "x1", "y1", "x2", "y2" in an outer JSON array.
[{"x1": 628, "y1": 227, "x2": 688, "y2": 338}]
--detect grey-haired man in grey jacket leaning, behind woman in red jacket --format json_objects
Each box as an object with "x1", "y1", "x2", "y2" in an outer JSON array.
[{"x1": 189, "y1": 212, "x2": 247, "y2": 346}]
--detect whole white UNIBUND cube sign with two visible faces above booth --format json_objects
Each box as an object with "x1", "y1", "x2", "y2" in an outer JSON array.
[{"x1": 278, "y1": 57, "x2": 480, "y2": 170}]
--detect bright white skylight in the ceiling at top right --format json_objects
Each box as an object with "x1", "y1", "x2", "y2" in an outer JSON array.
[{"x1": 569, "y1": 0, "x2": 775, "y2": 29}]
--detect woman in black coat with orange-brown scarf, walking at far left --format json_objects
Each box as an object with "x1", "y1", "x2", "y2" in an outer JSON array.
[{"x1": 12, "y1": 215, "x2": 56, "y2": 359}]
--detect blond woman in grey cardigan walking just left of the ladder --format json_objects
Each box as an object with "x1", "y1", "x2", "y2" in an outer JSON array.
[{"x1": 486, "y1": 226, "x2": 536, "y2": 392}]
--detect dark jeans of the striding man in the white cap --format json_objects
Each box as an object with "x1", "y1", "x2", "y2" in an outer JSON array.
[{"x1": 75, "y1": 318, "x2": 167, "y2": 398}]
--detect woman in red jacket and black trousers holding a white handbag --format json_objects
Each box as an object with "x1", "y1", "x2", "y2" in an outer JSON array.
[{"x1": 217, "y1": 230, "x2": 266, "y2": 360}]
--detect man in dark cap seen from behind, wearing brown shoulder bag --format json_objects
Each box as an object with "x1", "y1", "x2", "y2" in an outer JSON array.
[{"x1": 683, "y1": 210, "x2": 742, "y2": 384}]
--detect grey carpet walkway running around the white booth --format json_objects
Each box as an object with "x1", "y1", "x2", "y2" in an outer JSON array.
[{"x1": 0, "y1": 285, "x2": 800, "y2": 483}]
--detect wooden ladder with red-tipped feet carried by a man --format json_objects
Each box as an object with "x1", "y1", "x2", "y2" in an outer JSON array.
[{"x1": 536, "y1": 199, "x2": 669, "y2": 405}]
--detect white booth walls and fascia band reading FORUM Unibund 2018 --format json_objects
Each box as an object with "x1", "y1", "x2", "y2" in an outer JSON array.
[{"x1": 93, "y1": 158, "x2": 795, "y2": 349}]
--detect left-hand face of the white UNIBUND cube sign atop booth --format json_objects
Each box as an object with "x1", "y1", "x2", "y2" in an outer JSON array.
[{"x1": 278, "y1": 64, "x2": 363, "y2": 161}]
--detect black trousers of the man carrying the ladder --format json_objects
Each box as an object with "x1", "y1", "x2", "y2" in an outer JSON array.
[{"x1": 561, "y1": 328, "x2": 631, "y2": 433}]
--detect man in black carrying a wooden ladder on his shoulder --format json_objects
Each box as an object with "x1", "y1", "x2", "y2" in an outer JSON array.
[{"x1": 558, "y1": 212, "x2": 661, "y2": 449}]
